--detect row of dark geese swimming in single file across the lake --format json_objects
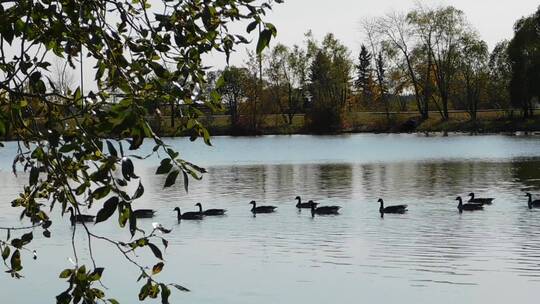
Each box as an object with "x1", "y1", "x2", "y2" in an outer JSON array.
[{"x1": 64, "y1": 193, "x2": 540, "y2": 225}]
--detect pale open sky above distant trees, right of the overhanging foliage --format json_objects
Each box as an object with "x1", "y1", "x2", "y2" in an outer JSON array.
[{"x1": 208, "y1": 0, "x2": 540, "y2": 66}]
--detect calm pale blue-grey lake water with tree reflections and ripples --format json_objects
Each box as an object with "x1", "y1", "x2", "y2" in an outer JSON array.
[{"x1": 0, "y1": 135, "x2": 540, "y2": 304}]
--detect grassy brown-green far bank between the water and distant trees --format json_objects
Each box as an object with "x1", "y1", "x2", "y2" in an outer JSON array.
[{"x1": 154, "y1": 110, "x2": 540, "y2": 136}]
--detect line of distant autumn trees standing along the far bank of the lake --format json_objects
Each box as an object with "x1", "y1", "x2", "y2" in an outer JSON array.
[{"x1": 201, "y1": 5, "x2": 540, "y2": 132}]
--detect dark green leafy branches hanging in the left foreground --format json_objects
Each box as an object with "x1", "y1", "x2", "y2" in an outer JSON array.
[{"x1": 0, "y1": 0, "x2": 282, "y2": 303}]
